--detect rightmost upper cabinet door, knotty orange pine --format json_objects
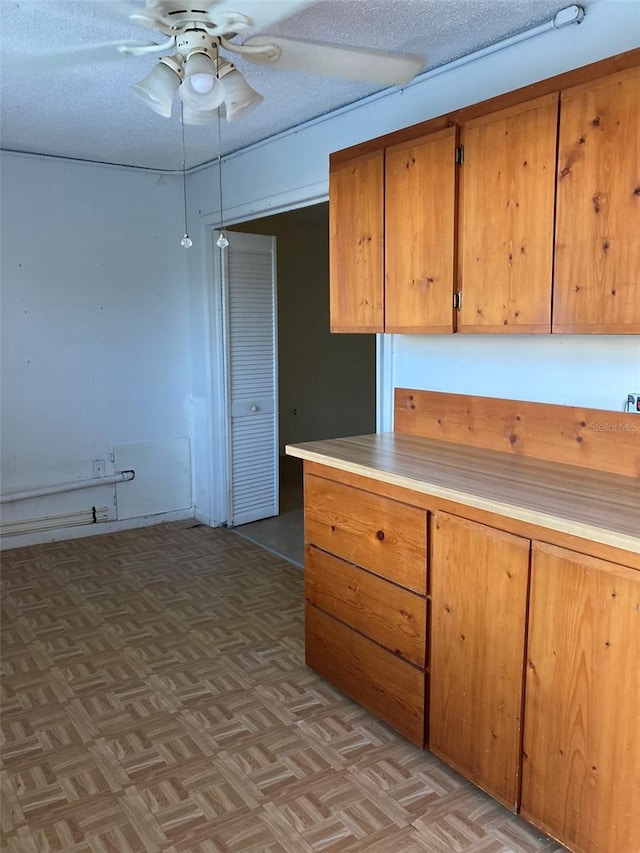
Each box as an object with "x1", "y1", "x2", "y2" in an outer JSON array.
[{"x1": 553, "y1": 68, "x2": 640, "y2": 334}]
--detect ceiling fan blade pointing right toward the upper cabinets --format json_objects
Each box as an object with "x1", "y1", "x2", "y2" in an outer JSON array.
[{"x1": 243, "y1": 36, "x2": 425, "y2": 86}]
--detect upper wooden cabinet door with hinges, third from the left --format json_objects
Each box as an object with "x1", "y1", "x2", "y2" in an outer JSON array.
[{"x1": 457, "y1": 93, "x2": 558, "y2": 332}]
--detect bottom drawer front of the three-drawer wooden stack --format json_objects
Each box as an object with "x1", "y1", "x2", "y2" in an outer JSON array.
[{"x1": 305, "y1": 605, "x2": 425, "y2": 747}]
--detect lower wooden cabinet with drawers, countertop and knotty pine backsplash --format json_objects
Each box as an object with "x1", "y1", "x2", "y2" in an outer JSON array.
[{"x1": 294, "y1": 388, "x2": 640, "y2": 853}]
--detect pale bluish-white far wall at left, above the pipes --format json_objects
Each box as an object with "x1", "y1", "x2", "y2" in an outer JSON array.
[{"x1": 1, "y1": 153, "x2": 191, "y2": 540}]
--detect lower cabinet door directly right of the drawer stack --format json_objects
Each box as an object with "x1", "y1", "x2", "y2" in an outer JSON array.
[{"x1": 429, "y1": 512, "x2": 530, "y2": 809}]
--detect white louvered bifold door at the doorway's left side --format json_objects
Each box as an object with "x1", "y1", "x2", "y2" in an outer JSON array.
[{"x1": 225, "y1": 232, "x2": 279, "y2": 526}]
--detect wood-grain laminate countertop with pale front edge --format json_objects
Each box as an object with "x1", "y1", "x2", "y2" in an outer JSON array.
[{"x1": 285, "y1": 433, "x2": 640, "y2": 553}]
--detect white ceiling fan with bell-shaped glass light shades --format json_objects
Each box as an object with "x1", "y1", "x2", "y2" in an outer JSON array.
[{"x1": 41, "y1": 0, "x2": 424, "y2": 125}]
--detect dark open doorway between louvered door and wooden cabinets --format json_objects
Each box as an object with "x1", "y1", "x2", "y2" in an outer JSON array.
[{"x1": 229, "y1": 202, "x2": 376, "y2": 566}]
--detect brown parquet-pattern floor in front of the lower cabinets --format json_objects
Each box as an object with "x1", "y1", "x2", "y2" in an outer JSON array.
[{"x1": 0, "y1": 522, "x2": 561, "y2": 853}]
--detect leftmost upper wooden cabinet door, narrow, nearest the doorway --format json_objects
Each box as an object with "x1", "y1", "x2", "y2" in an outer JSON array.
[{"x1": 329, "y1": 151, "x2": 384, "y2": 332}]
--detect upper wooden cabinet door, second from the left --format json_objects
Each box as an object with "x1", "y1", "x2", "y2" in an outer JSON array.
[{"x1": 385, "y1": 127, "x2": 457, "y2": 333}]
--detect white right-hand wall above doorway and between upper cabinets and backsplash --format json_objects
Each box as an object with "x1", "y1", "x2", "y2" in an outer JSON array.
[{"x1": 190, "y1": 0, "x2": 640, "y2": 520}]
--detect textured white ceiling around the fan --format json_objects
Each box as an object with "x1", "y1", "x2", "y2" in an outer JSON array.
[{"x1": 0, "y1": 0, "x2": 598, "y2": 171}]
